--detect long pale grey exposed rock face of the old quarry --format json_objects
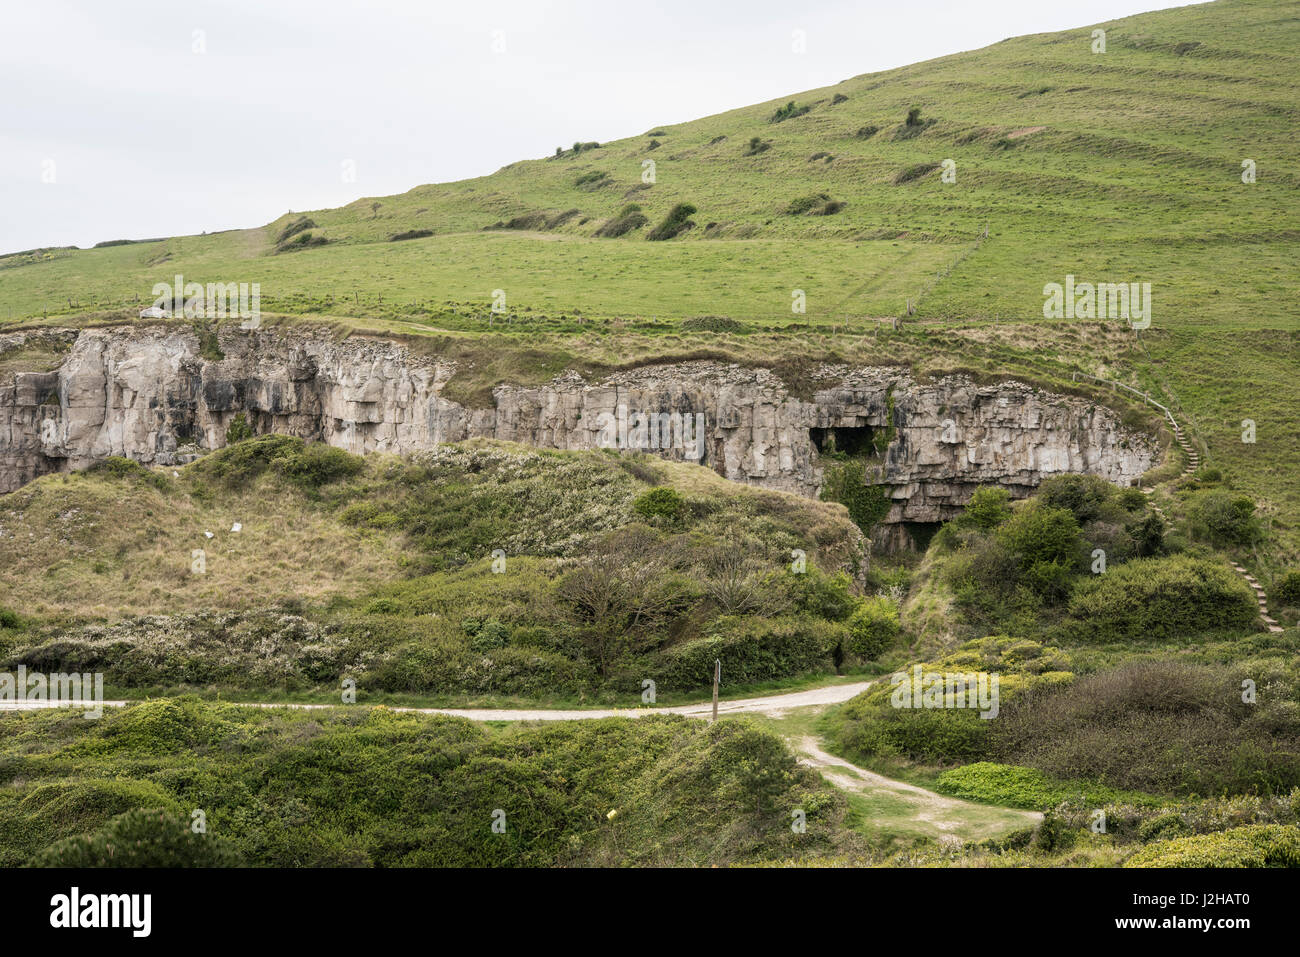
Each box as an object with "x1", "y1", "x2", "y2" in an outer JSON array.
[{"x1": 0, "y1": 326, "x2": 1157, "y2": 538}]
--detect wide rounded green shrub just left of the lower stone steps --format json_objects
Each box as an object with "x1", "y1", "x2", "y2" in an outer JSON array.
[{"x1": 1069, "y1": 555, "x2": 1258, "y2": 642}]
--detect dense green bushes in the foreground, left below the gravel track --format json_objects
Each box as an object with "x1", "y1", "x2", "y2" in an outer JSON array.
[{"x1": 0, "y1": 702, "x2": 854, "y2": 867}]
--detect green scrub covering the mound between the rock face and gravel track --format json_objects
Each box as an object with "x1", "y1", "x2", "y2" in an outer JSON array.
[{"x1": 0, "y1": 436, "x2": 873, "y2": 701}]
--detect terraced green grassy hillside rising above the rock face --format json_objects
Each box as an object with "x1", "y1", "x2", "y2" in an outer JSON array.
[{"x1": 0, "y1": 0, "x2": 1300, "y2": 329}]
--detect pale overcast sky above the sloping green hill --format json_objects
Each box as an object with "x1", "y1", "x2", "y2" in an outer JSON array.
[{"x1": 0, "y1": 0, "x2": 1201, "y2": 252}]
